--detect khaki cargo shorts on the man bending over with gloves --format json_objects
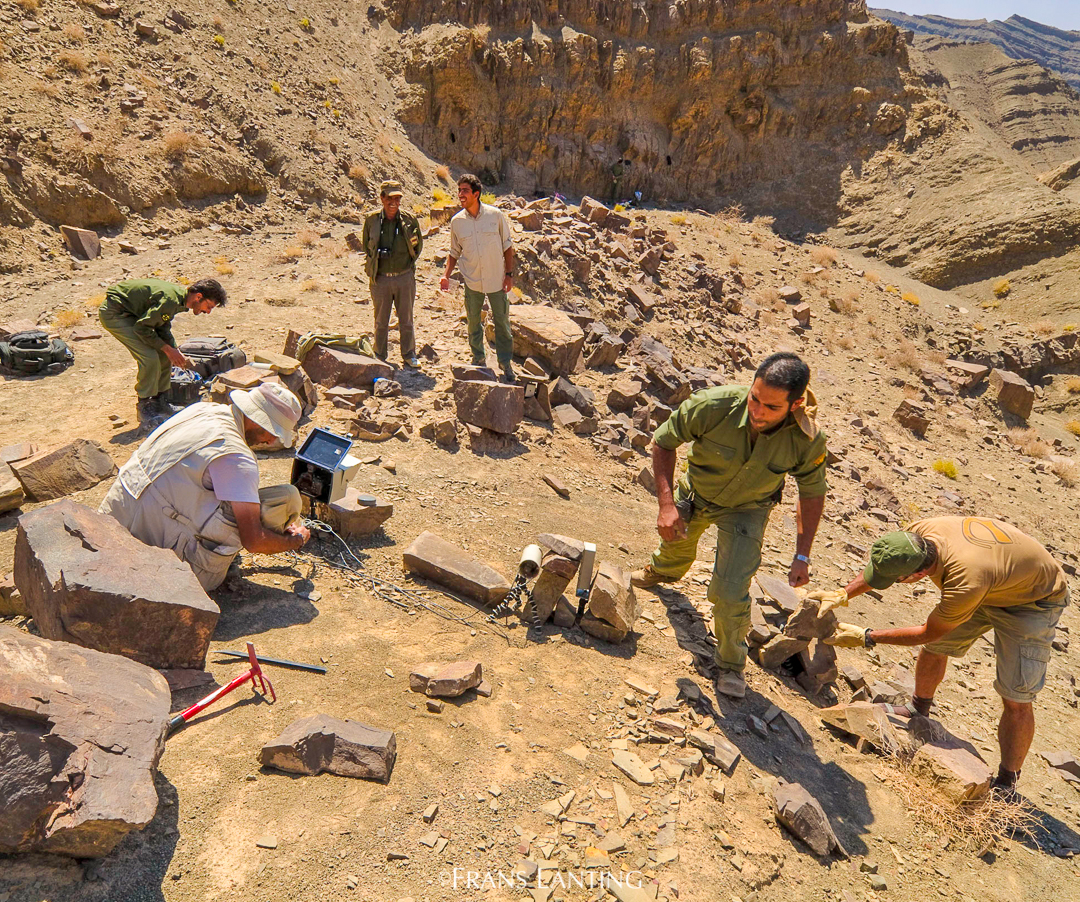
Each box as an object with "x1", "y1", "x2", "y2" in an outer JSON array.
[{"x1": 923, "y1": 591, "x2": 1069, "y2": 703}]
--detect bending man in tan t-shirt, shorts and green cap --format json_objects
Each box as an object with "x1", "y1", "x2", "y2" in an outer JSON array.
[{"x1": 821, "y1": 516, "x2": 1069, "y2": 795}]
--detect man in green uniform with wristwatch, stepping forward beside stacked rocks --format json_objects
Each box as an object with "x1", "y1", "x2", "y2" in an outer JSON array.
[{"x1": 632, "y1": 353, "x2": 827, "y2": 698}]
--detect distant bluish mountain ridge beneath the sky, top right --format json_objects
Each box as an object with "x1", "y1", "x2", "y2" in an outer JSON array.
[{"x1": 872, "y1": 10, "x2": 1080, "y2": 87}]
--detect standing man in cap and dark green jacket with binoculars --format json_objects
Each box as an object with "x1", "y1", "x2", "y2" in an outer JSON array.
[{"x1": 363, "y1": 180, "x2": 423, "y2": 367}]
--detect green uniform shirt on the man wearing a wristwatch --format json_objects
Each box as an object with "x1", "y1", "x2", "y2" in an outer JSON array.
[{"x1": 652, "y1": 386, "x2": 828, "y2": 509}]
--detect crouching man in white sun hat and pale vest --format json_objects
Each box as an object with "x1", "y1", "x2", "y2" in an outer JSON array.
[{"x1": 98, "y1": 385, "x2": 311, "y2": 591}]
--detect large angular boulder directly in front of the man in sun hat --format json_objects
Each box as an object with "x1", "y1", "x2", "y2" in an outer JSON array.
[{"x1": 15, "y1": 500, "x2": 220, "y2": 670}]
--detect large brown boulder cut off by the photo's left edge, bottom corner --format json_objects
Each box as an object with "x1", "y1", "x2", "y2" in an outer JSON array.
[{"x1": 0, "y1": 627, "x2": 171, "y2": 858}]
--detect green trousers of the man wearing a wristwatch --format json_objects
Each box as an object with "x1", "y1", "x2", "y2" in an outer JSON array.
[{"x1": 651, "y1": 482, "x2": 772, "y2": 671}]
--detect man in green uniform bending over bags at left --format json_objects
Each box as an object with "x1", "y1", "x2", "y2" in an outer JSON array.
[{"x1": 97, "y1": 279, "x2": 226, "y2": 427}]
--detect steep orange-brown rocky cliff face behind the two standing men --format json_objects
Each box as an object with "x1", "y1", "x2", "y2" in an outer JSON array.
[{"x1": 388, "y1": 0, "x2": 906, "y2": 218}]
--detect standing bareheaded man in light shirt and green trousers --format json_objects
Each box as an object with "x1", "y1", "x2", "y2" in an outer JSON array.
[{"x1": 440, "y1": 175, "x2": 516, "y2": 382}]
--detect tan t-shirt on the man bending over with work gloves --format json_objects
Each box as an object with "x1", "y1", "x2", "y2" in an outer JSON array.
[{"x1": 907, "y1": 516, "x2": 1067, "y2": 625}]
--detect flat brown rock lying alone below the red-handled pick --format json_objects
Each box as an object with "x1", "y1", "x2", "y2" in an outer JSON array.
[{"x1": 259, "y1": 714, "x2": 397, "y2": 783}]
